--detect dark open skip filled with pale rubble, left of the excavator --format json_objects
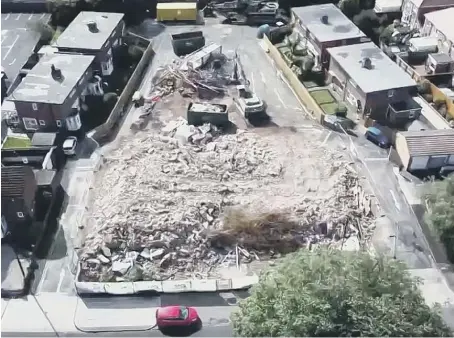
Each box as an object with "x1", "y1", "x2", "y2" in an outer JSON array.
[{"x1": 187, "y1": 102, "x2": 230, "y2": 127}]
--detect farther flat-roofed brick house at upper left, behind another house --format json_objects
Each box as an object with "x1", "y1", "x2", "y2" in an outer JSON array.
[{"x1": 52, "y1": 12, "x2": 125, "y2": 76}]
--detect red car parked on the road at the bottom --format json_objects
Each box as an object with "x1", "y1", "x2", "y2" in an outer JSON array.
[{"x1": 156, "y1": 305, "x2": 202, "y2": 331}]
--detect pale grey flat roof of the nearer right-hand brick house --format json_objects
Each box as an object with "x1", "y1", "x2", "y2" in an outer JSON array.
[{"x1": 327, "y1": 42, "x2": 416, "y2": 93}]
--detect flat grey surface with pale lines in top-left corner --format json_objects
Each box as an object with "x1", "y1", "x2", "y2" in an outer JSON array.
[{"x1": 1, "y1": 13, "x2": 50, "y2": 81}]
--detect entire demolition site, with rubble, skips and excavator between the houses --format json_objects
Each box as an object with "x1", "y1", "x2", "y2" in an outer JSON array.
[{"x1": 78, "y1": 26, "x2": 375, "y2": 282}]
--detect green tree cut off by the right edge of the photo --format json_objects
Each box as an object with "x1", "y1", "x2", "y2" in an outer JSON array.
[{"x1": 426, "y1": 175, "x2": 454, "y2": 262}]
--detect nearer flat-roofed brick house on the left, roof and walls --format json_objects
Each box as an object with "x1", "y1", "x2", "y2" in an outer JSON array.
[{"x1": 7, "y1": 53, "x2": 95, "y2": 132}]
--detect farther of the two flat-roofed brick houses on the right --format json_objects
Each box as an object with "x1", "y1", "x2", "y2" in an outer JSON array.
[{"x1": 292, "y1": 4, "x2": 370, "y2": 69}]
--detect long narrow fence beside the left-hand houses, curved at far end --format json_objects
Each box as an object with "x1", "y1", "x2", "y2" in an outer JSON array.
[{"x1": 91, "y1": 35, "x2": 155, "y2": 142}]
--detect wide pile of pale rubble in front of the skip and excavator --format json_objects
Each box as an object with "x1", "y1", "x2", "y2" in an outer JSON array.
[{"x1": 81, "y1": 120, "x2": 373, "y2": 281}]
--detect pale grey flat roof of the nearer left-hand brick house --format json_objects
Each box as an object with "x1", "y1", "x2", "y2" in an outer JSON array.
[{"x1": 9, "y1": 53, "x2": 95, "y2": 104}]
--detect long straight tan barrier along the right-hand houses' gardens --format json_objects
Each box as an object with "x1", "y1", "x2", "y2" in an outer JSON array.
[{"x1": 262, "y1": 35, "x2": 325, "y2": 123}]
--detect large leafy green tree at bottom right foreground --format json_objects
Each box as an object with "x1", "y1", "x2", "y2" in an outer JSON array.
[{"x1": 232, "y1": 249, "x2": 450, "y2": 337}]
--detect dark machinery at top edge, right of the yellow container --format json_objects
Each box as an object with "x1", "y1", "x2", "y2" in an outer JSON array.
[{"x1": 212, "y1": 0, "x2": 289, "y2": 25}]
